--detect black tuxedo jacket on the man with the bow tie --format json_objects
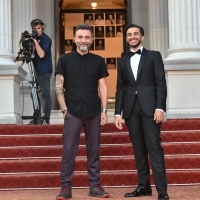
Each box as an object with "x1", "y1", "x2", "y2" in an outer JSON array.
[{"x1": 115, "y1": 48, "x2": 167, "y2": 119}]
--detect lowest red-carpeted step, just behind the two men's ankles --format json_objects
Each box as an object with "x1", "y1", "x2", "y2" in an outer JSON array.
[{"x1": 0, "y1": 170, "x2": 200, "y2": 189}]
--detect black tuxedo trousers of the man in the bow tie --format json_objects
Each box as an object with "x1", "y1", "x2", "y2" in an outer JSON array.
[{"x1": 125, "y1": 97, "x2": 167, "y2": 192}]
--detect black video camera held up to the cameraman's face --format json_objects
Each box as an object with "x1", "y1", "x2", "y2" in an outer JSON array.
[{"x1": 20, "y1": 30, "x2": 37, "y2": 62}]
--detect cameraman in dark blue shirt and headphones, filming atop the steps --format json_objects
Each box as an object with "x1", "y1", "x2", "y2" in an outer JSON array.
[{"x1": 29, "y1": 19, "x2": 52, "y2": 124}]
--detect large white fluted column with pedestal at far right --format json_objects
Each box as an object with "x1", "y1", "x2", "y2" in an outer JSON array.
[{"x1": 164, "y1": 0, "x2": 200, "y2": 118}]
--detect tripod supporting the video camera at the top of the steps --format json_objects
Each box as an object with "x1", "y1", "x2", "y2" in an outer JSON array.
[{"x1": 16, "y1": 50, "x2": 42, "y2": 125}]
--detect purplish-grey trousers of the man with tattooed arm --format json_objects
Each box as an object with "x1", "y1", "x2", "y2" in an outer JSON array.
[{"x1": 60, "y1": 112, "x2": 101, "y2": 188}]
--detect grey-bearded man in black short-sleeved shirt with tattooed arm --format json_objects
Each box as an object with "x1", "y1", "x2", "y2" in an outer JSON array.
[{"x1": 55, "y1": 24, "x2": 110, "y2": 200}]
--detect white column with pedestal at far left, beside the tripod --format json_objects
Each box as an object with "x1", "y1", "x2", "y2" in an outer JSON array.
[{"x1": 0, "y1": 0, "x2": 26, "y2": 124}]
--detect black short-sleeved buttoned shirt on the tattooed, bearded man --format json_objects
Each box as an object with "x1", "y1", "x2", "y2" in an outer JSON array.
[{"x1": 55, "y1": 51, "x2": 109, "y2": 120}]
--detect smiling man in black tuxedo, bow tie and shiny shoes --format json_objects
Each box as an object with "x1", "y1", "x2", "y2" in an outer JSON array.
[{"x1": 115, "y1": 24, "x2": 169, "y2": 200}]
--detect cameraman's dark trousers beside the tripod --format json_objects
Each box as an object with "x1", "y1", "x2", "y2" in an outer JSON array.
[{"x1": 37, "y1": 73, "x2": 52, "y2": 122}]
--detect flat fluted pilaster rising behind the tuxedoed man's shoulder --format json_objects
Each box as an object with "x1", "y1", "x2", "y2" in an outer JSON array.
[{"x1": 148, "y1": 0, "x2": 169, "y2": 59}]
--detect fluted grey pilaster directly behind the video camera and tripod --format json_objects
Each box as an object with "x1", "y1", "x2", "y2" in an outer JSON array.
[{"x1": 12, "y1": 0, "x2": 37, "y2": 121}]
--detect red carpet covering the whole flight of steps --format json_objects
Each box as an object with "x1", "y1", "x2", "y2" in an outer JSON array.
[{"x1": 0, "y1": 119, "x2": 200, "y2": 189}]
